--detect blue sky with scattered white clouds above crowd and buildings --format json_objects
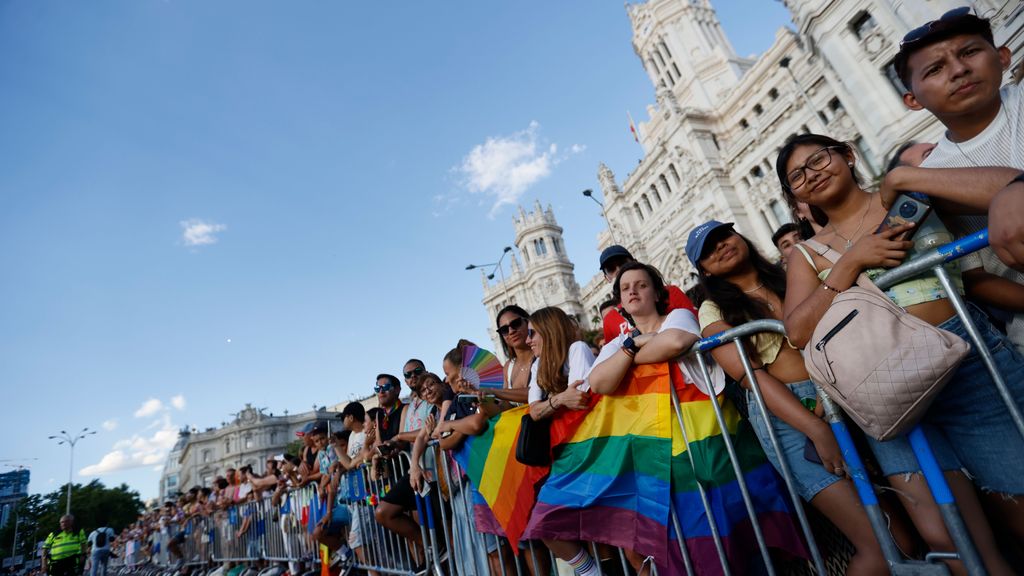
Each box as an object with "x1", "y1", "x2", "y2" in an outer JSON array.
[{"x1": 0, "y1": 0, "x2": 788, "y2": 497}]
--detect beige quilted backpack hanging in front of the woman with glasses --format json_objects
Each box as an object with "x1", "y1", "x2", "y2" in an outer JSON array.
[{"x1": 804, "y1": 240, "x2": 969, "y2": 440}]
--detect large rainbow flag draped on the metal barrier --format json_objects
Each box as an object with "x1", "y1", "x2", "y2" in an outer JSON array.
[{"x1": 456, "y1": 363, "x2": 806, "y2": 574}]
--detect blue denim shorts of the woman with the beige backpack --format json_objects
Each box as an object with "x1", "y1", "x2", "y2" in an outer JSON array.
[{"x1": 869, "y1": 305, "x2": 1024, "y2": 494}]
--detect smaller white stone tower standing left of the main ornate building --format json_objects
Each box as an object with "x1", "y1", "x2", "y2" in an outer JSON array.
[{"x1": 481, "y1": 202, "x2": 590, "y2": 354}]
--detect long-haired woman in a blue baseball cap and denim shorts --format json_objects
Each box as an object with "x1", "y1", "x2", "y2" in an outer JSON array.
[{"x1": 686, "y1": 220, "x2": 897, "y2": 575}]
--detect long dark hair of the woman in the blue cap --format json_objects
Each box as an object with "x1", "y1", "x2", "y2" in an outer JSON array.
[{"x1": 698, "y1": 232, "x2": 785, "y2": 326}]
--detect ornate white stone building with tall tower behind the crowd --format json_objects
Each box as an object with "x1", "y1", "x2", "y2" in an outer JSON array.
[{"x1": 484, "y1": 0, "x2": 1024, "y2": 334}]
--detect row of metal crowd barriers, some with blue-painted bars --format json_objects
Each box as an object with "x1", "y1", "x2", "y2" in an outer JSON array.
[{"x1": 103, "y1": 231, "x2": 1024, "y2": 576}]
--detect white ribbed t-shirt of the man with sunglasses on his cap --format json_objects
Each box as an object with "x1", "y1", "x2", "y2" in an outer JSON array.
[{"x1": 922, "y1": 79, "x2": 1024, "y2": 353}]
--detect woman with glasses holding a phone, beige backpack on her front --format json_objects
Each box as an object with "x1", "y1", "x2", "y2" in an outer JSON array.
[{"x1": 776, "y1": 134, "x2": 1024, "y2": 573}]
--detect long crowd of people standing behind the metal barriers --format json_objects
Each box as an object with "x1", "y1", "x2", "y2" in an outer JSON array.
[{"x1": 88, "y1": 8, "x2": 1024, "y2": 576}]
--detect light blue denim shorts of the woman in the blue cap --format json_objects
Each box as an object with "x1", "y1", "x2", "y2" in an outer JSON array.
[{"x1": 746, "y1": 380, "x2": 842, "y2": 502}]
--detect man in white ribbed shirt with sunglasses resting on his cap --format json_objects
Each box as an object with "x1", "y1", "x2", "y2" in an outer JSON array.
[{"x1": 883, "y1": 6, "x2": 1024, "y2": 270}]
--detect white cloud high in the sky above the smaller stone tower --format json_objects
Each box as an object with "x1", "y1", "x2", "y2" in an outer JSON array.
[{"x1": 456, "y1": 121, "x2": 586, "y2": 217}]
